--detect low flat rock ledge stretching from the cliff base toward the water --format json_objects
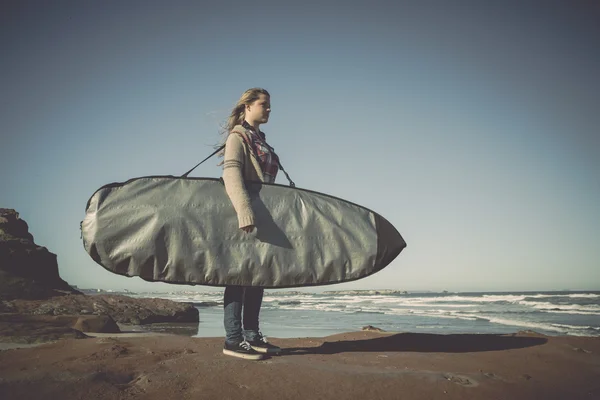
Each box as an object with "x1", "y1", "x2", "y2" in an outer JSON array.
[{"x1": 0, "y1": 295, "x2": 200, "y2": 325}]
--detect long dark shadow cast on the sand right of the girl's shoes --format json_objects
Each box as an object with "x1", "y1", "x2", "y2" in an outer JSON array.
[{"x1": 281, "y1": 333, "x2": 548, "y2": 356}]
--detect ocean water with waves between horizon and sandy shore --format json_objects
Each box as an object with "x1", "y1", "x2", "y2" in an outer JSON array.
[{"x1": 127, "y1": 290, "x2": 600, "y2": 338}]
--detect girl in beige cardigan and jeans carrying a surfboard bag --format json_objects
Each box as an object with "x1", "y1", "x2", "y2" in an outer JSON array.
[{"x1": 223, "y1": 88, "x2": 281, "y2": 360}]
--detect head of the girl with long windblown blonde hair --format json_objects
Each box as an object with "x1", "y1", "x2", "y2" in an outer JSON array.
[{"x1": 225, "y1": 88, "x2": 271, "y2": 133}]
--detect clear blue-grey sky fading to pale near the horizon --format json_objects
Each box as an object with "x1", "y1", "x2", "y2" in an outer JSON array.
[{"x1": 0, "y1": 0, "x2": 600, "y2": 291}]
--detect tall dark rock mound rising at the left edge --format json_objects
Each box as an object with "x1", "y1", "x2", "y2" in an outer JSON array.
[{"x1": 0, "y1": 208, "x2": 80, "y2": 300}]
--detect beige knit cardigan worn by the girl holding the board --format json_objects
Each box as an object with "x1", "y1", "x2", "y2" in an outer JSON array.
[{"x1": 223, "y1": 125, "x2": 265, "y2": 228}]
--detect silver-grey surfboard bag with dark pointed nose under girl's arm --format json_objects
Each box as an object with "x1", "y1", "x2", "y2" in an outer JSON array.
[{"x1": 81, "y1": 176, "x2": 406, "y2": 288}]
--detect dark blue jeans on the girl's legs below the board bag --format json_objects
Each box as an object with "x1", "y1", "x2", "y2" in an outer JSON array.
[{"x1": 223, "y1": 286, "x2": 265, "y2": 343}]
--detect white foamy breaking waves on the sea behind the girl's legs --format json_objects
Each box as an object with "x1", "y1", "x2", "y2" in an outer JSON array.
[{"x1": 134, "y1": 292, "x2": 600, "y2": 336}]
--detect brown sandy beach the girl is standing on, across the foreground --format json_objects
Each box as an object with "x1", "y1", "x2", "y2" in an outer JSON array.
[{"x1": 0, "y1": 332, "x2": 600, "y2": 400}]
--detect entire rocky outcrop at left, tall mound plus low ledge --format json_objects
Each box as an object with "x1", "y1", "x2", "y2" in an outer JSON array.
[{"x1": 0, "y1": 208, "x2": 199, "y2": 343}]
